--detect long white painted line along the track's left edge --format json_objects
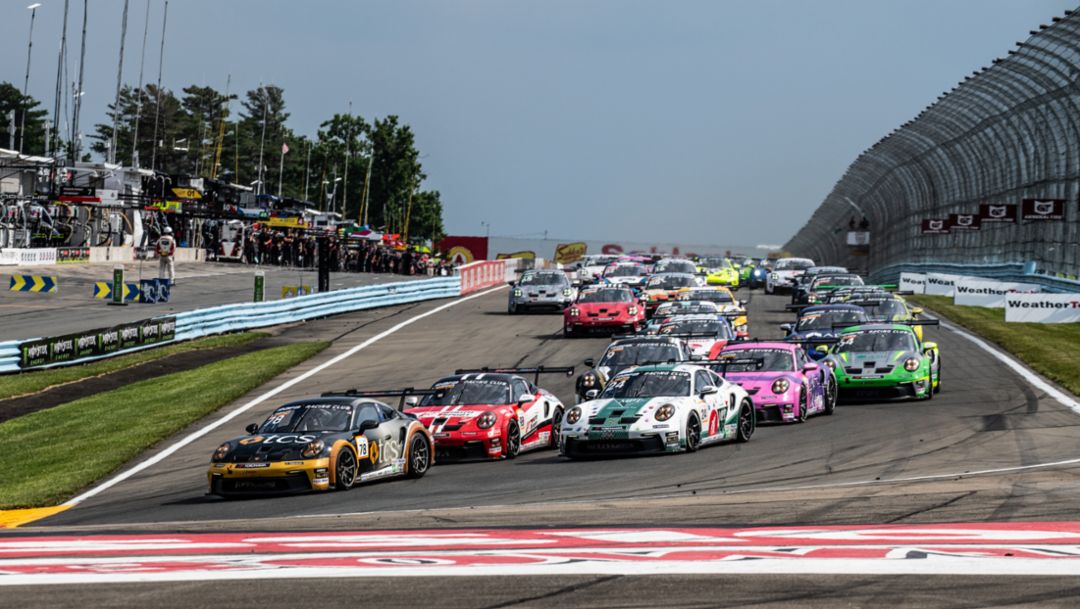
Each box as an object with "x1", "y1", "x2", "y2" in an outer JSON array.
[{"x1": 63, "y1": 285, "x2": 505, "y2": 506}]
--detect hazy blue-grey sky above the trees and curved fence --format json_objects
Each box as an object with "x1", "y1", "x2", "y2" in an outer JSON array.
[{"x1": 0, "y1": 0, "x2": 1077, "y2": 245}]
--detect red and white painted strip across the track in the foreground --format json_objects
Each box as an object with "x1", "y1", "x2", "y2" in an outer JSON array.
[{"x1": 0, "y1": 523, "x2": 1080, "y2": 585}]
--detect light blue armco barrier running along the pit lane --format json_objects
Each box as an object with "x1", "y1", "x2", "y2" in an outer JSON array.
[{"x1": 0, "y1": 278, "x2": 460, "y2": 373}]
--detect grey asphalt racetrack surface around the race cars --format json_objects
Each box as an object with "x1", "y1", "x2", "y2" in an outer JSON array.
[{"x1": 5, "y1": 290, "x2": 1080, "y2": 607}]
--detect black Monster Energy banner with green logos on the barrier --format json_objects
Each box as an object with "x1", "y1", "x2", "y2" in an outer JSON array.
[{"x1": 18, "y1": 317, "x2": 176, "y2": 368}]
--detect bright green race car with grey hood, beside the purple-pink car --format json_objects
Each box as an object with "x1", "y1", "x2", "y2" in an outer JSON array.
[{"x1": 824, "y1": 320, "x2": 942, "y2": 400}]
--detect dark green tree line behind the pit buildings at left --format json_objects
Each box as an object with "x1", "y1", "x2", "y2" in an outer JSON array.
[{"x1": 0, "y1": 82, "x2": 443, "y2": 240}]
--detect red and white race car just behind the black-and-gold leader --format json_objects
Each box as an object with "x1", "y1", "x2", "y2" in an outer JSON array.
[{"x1": 405, "y1": 366, "x2": 573, "y2": 459}]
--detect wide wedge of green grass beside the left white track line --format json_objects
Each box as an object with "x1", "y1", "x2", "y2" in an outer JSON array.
[{"x1": 0, "y1": 342, "x2": 328, "y2": 509}]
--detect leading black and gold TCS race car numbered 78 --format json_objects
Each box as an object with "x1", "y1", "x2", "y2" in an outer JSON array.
[{"x1": 206, "y1": 391, "x2": 435, "y2": 497}]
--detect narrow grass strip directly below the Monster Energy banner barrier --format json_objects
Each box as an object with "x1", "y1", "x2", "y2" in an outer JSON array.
[{"x1": 0, "y1": 331, "x2": 267, "y2": 400}]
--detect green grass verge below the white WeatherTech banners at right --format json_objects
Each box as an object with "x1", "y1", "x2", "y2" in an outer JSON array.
[{"x1": 907, "y1": 295, "x2": 1080, "y2": 394}]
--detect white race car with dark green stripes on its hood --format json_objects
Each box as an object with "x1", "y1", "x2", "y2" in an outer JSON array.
[{"x1": 559, "y1": 364, "x2": 757, "y2": 458}]
